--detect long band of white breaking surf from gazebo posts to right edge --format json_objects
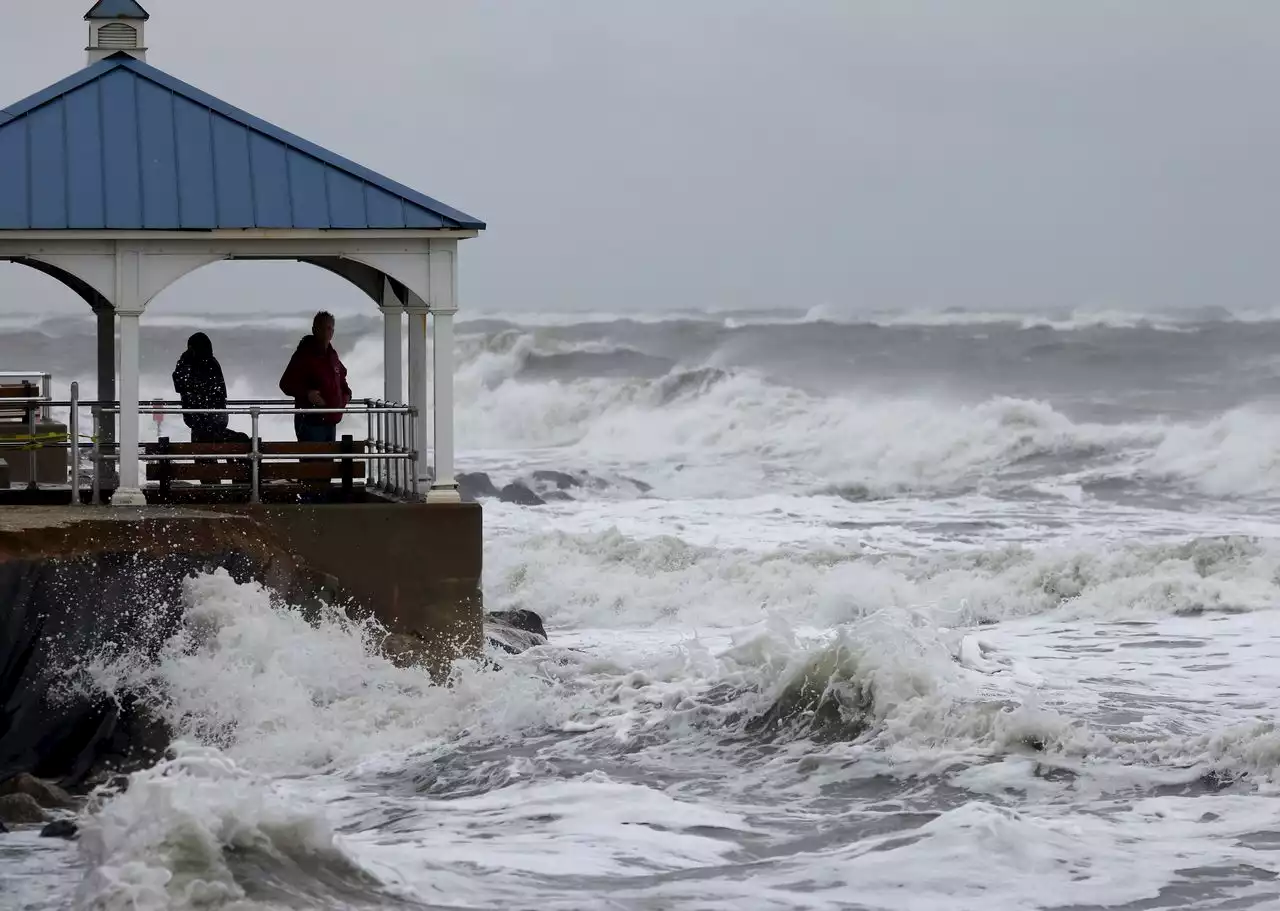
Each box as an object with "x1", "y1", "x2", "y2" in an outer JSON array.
[{"x1": 422, "y1": 330, "x2": 1280, "y2": 499}]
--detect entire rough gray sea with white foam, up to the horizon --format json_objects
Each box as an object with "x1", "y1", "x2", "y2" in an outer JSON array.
[{"x1": 0, "y1": 311, "x2": 1280, "y2": 911}]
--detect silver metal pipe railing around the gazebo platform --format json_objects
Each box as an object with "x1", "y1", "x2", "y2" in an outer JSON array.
[{"x1": 0, "y1": 383, "x2": 419, "y2": 505}]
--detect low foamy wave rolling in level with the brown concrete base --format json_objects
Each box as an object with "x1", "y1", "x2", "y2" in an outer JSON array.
[{"x1": 485, "y1": 530, "x2": 1280, "y2": 628}]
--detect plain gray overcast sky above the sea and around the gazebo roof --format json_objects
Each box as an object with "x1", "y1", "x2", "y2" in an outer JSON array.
[{"x1": 0, "y1": 0, "x2": 1280, "y2": 317}]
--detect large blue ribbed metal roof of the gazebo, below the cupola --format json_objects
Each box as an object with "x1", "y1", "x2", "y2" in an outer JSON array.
[{"x1": 0, "y1": 54, "x2": 485, "y2": 230}]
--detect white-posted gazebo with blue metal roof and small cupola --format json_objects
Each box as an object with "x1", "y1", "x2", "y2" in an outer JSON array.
[{"x1": 0, "y1": 0, "x2": 485, "y2": 505}]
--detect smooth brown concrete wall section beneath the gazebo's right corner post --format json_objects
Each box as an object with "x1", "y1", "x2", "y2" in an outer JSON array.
[{"x1": 225, "y1": 503, "x2": 484, "y2": 656}]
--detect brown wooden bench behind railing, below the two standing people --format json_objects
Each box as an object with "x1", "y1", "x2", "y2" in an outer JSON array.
[{"x1": 142, "y1": 435, "x2": 369, "y2": 500}]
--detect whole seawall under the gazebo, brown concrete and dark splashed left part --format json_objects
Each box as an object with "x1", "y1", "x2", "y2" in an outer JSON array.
[{"x1": 0, "y1": 504, "x2": 483, "y2": 784}]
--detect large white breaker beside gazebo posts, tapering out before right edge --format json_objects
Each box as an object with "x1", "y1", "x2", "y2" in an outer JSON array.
[{"x1": 458, "y1": 348, "x2": 1160, "y2": 496}]
